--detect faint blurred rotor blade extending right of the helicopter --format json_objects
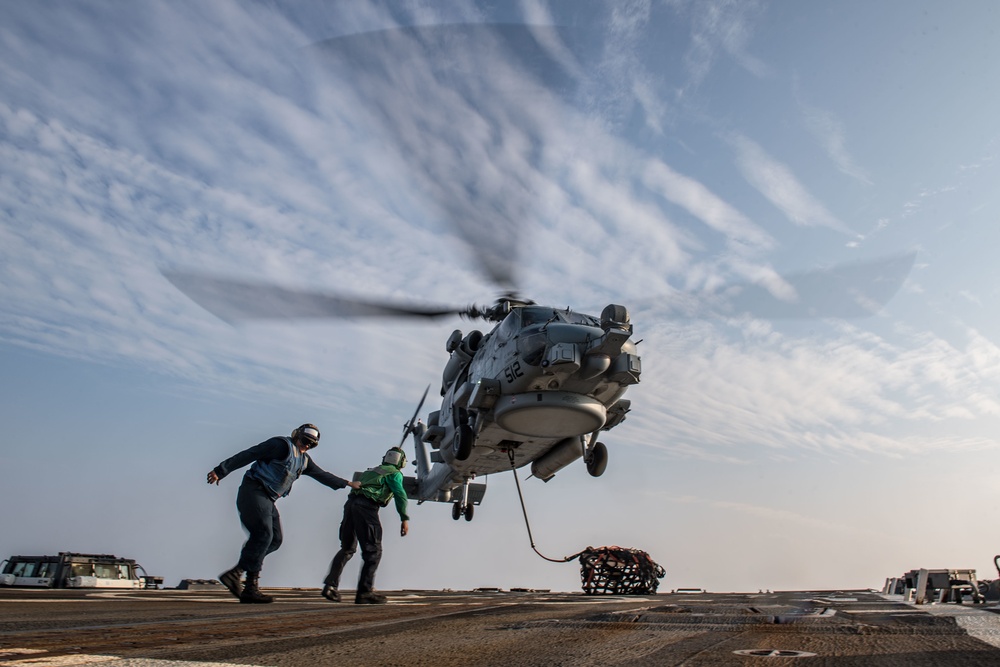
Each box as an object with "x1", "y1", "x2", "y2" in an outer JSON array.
[{"x1": 668, "y1": 253, "x2": 916, "y2": 319}]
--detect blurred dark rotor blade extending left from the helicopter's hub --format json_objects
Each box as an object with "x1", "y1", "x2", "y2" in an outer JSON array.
[{"x1": 162, "y1": 271, "x2": 474, "y2": 322}]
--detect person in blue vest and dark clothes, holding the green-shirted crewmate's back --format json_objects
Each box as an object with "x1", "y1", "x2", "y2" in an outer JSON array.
[{"x1": 208, "y1": 424, "x2": 360, "y2": 603}]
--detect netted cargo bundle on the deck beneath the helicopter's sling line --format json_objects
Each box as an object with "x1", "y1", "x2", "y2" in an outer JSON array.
[{"x1": 567, "y1": 547, "x2": 666, "y2": 595}]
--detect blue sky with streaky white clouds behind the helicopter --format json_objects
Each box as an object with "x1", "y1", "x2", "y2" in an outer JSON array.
[{"x1": 0, "y1": 0, "x2": 1000, "y2": 591}]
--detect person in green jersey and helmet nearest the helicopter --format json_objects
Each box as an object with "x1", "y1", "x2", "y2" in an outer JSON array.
[{"x1": 323, "y1": 447, "x2": 410, "y2": 604}]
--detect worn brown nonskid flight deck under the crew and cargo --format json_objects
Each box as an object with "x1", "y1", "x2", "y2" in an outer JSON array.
[{"x1": 0, "y1": 589, "x2": 1000, "y2": 667}]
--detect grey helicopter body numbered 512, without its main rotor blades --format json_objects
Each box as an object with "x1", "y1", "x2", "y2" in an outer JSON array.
[{"x1": 409, "y1": 301, "x2": 641, "y2": 519}]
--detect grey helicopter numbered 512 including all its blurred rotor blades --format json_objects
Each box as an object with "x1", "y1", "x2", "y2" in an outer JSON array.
[{"x1": 162, "y1": 24, "x2": 913, "y2": 521}]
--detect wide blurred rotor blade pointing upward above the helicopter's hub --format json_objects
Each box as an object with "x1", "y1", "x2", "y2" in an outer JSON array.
[{"x1": 312, "y1": 23, "x2": 579, "y2": 291}]
